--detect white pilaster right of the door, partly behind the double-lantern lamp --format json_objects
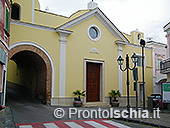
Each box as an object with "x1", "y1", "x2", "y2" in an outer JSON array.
[{"x1": 116, "y1": 41, "x2": 126, "y2": 95}]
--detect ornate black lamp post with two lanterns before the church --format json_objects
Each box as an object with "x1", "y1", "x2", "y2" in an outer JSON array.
[{"x1": 117, "y1": 53, "x2": 137, "y2": 112}]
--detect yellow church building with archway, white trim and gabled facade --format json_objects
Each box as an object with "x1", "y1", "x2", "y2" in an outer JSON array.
[{"x1": 7, "y1": 0, "x2": 153, "y2": 106}]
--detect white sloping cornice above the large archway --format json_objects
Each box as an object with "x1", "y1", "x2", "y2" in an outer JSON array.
[{"x1": 10, "y1": 20, "x2": 56, "y2": 32}]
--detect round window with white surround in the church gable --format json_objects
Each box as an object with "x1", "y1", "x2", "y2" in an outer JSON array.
[{"x1": 88, "y1": 25, "x2": 101, "y2": 41}]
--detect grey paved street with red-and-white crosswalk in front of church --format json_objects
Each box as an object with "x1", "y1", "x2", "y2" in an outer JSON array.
[{"x1": 7, "y1": 89, "x2": 170, "y2": 128}]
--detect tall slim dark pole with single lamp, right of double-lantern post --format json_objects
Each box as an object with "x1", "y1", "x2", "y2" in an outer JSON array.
[{"x1": 140, "y1": 39, "x2": 146, "y2": 110}]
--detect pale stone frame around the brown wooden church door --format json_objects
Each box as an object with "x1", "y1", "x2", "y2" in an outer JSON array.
[{"x1": 84, "y1": 59, "x2": 105, "y2": 104}]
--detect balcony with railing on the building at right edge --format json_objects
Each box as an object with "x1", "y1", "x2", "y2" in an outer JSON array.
[{"x1": 160, "y1": 58, "x2": 170, "y2": 74}]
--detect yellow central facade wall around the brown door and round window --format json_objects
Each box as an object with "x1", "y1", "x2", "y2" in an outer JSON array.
[{"x1": 66, "y1": 17, "x2": 119, "y2": 96}]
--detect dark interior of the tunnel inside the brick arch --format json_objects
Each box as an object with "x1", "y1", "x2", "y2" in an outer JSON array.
[{"x1": 7, "y1": 51, "x2": 47, "y2": 103}]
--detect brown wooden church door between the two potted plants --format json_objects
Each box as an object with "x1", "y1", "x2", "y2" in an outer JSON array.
[{"x1": 86, "y1": 63, "x2": 101, "y2": 102}]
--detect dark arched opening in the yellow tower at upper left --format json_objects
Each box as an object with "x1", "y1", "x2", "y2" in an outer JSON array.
[{"x1": 11, "y1": 3, "x2": 21, "y2": 20}]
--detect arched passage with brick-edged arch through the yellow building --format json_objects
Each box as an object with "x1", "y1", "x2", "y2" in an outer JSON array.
[{"x1": 7, "y1": 43, "x2": 53, "y2": 104}]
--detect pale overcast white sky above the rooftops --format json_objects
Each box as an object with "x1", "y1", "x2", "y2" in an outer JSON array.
[{"x1": 39, "y1": 0, "x2": 170, "y2": 43}]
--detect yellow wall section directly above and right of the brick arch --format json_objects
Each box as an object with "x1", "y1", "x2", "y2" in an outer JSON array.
[{"x1": 7, "y1": 24, "x2": 60, "y2": 95}]
